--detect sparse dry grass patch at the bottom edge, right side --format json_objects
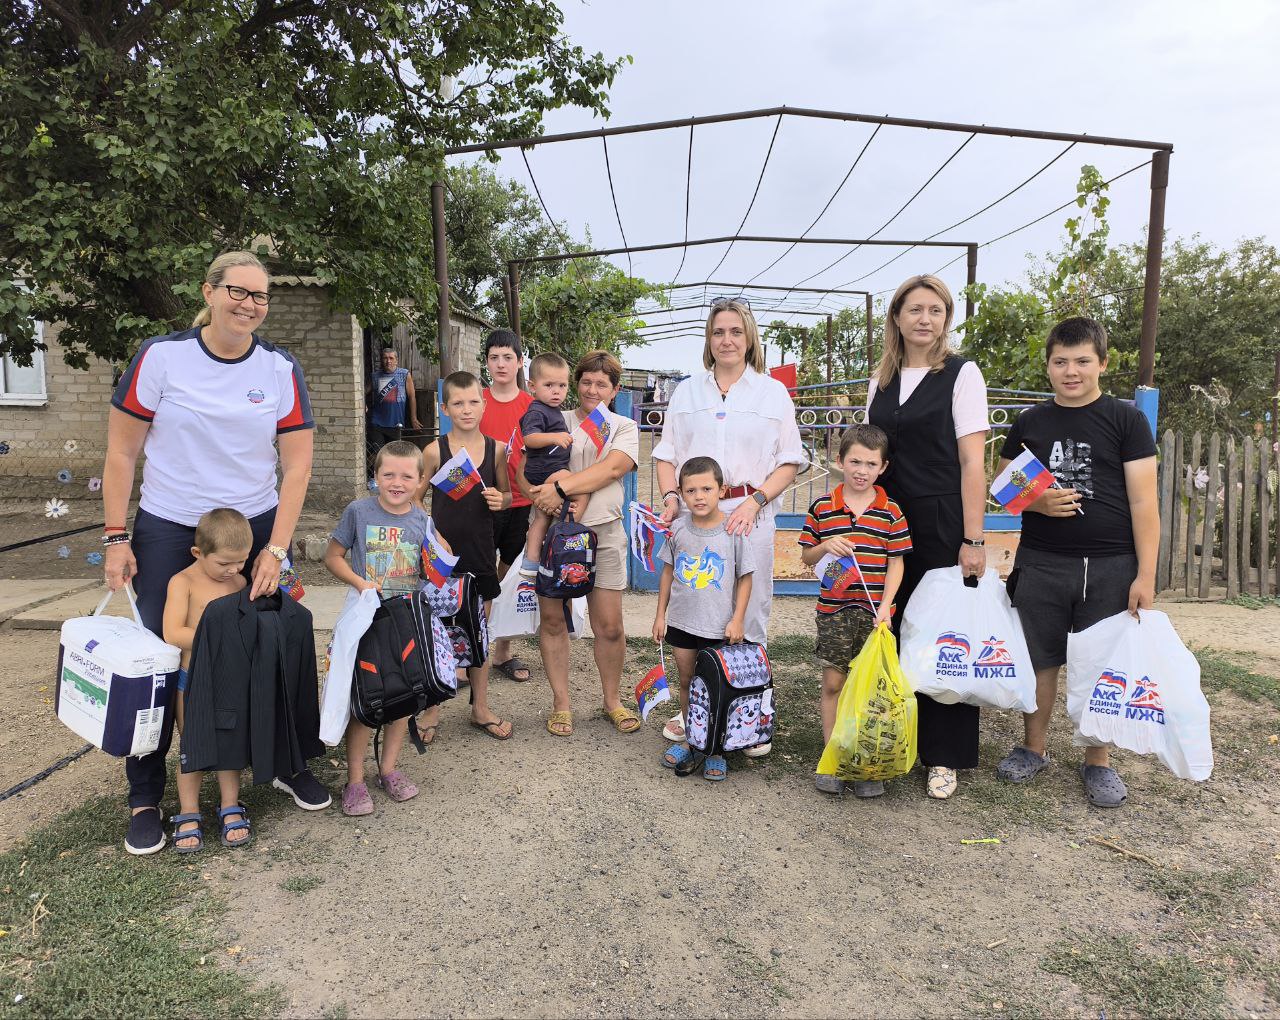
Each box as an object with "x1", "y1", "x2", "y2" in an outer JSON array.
[{"x1": 1039, "y1": 932, "x2": 1226, "y2": 1017}]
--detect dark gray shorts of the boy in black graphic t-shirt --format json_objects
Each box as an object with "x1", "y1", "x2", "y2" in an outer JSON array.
[{"x1": 1007, "y1": 545, "x2": 1138, "y2": 669}]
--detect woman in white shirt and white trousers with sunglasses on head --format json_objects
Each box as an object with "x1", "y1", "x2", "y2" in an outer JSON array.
[{"x1": 653, "y1": 299, "x2": 806, "y2": 758}]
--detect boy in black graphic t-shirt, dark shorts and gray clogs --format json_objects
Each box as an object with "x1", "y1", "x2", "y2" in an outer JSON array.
[{"x1": 996, "y1": 317, "x2": 1160, "y2": 808}]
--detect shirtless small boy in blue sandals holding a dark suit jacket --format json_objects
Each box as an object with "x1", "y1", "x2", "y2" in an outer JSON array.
[{"x1": 164, "y1": 507, "x2": 253, "y2": 854}]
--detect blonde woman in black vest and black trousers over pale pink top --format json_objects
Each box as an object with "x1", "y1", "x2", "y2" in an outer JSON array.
[{"x1": 867, "y1": 276, "x2": 987, "y2": 800}]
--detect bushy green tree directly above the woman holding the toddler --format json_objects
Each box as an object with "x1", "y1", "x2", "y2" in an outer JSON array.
[{"x1": 520, "y1": 259, "x2": 669, "y2": 365}]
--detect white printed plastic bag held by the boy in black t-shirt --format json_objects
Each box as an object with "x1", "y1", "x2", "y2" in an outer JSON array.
[{"x1": 1066, "y1": 609, "x2": 1213, "y2": 781}]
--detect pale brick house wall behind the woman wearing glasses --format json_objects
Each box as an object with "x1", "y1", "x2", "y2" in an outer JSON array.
[{"x1": 0, "y1": 276, "x2": 488, "y2": 508}]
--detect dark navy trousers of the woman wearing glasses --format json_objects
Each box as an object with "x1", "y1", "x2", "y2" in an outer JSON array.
[{"x1": 124, "y1": 507, "x2": 275, "y2": 808}]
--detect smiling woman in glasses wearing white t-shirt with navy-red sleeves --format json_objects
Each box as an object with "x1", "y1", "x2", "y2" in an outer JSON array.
[{"x1": 102, "y1": 251, "x2": 330, "y2": 855}]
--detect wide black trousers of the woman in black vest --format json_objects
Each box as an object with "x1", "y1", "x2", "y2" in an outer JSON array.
[{"x1": 893, "y1": 493, "x2": 979, "y2": 769}]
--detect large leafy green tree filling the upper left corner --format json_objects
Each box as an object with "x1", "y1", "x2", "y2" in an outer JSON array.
[{"x1": 0, "y1": 0, "x2": 622, "y2": 365}]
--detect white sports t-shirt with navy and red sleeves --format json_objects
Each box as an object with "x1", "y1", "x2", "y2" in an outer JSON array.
[{"x1": 111, "y1": 329, "x2": 315, "y2": 527}]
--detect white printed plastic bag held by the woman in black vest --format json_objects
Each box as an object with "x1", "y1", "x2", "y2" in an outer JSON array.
[{"x1": 900, "y1": 567, "x2": 1036, "y2": 712}]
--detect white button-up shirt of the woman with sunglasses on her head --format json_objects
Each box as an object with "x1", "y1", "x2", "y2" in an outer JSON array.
[{"x1": 653, "y1": 369, "x2": 808, "y2": 506}]
